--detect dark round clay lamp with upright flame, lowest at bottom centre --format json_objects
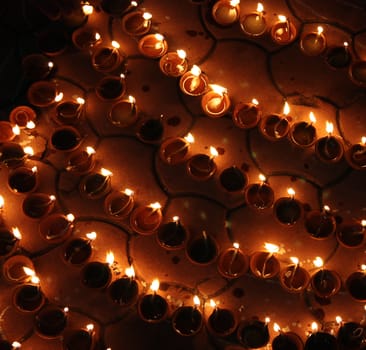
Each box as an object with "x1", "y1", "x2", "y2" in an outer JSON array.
[{"x1": 172, "y1": 295, "x2": 203, "y2": 336}]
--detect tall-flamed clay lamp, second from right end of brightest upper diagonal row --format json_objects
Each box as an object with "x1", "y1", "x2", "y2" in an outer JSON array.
[{"x1": 315, "y1": 121, "x2": 344, "y2": 163}]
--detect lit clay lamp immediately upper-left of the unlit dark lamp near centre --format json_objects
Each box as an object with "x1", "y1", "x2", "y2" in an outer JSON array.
[{"x1": 187, "y1": 146, "x2": 218, "y2": 181}]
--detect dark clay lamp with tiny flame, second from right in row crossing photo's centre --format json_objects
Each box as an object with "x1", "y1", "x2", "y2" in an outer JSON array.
[{"x1": 305, "y1": 205, "x2": 337, "y2": 239}]
